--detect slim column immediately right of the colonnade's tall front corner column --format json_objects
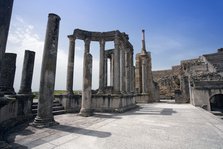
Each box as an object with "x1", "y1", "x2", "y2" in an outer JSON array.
[{"x1": 120, "y1": 46, "x2": 126, "y2": 93}]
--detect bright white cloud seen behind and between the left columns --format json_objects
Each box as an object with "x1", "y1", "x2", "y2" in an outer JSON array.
[{"x1": 6, "y1": 16, "x2": 99, "y2": 91}]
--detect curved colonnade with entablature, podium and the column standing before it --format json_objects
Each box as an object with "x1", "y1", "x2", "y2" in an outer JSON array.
[{"x1": 63, "y1": 29, "x2": 135, "y2": 116}]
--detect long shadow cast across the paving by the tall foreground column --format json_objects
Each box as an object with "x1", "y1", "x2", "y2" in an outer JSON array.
[{"x1": 49, "y1": 125, "x2": 111, "y2": 138}]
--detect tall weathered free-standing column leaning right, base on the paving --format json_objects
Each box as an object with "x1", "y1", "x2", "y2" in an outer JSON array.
[{"x1": 33, "y1": 13, "x2": 60, "y2": 127}]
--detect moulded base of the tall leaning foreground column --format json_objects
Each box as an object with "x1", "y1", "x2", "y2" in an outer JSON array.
[{"x1": 30, "y1": 116, "x2": 59, "y2": 128}]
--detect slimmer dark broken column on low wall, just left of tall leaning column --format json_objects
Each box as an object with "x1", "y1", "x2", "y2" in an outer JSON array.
[{"x1": 18, "y1": 50, "x2": 35, "y2": 94}]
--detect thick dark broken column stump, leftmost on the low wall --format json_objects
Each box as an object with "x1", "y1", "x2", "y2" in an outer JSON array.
[{"x1": 0, "y1": 53, "x2": 17, "y2": 95}]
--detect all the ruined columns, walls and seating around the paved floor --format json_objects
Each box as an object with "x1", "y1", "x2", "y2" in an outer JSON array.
[{"x1": 0, "y1": 0, "x2": 223, "y2": 148}]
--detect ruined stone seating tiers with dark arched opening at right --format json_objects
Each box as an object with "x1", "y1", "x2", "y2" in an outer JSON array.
[{"x1": 153, "y1": 48, "x2": 223, "y2": 111}]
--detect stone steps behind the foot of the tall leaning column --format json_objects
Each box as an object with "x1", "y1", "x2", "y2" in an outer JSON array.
[{"x1": 32, "y1": 100, "x2": 66, "y2": 117}]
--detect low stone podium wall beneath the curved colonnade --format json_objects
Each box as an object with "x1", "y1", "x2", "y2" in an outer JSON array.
[{"x1": 55, "y1": 94, "x2": 137, "y2": 112}]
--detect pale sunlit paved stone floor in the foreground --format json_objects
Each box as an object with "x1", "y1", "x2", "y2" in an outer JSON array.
[{"x1": 6, "y1": 103, "x2": 223, "y2": 149}]
